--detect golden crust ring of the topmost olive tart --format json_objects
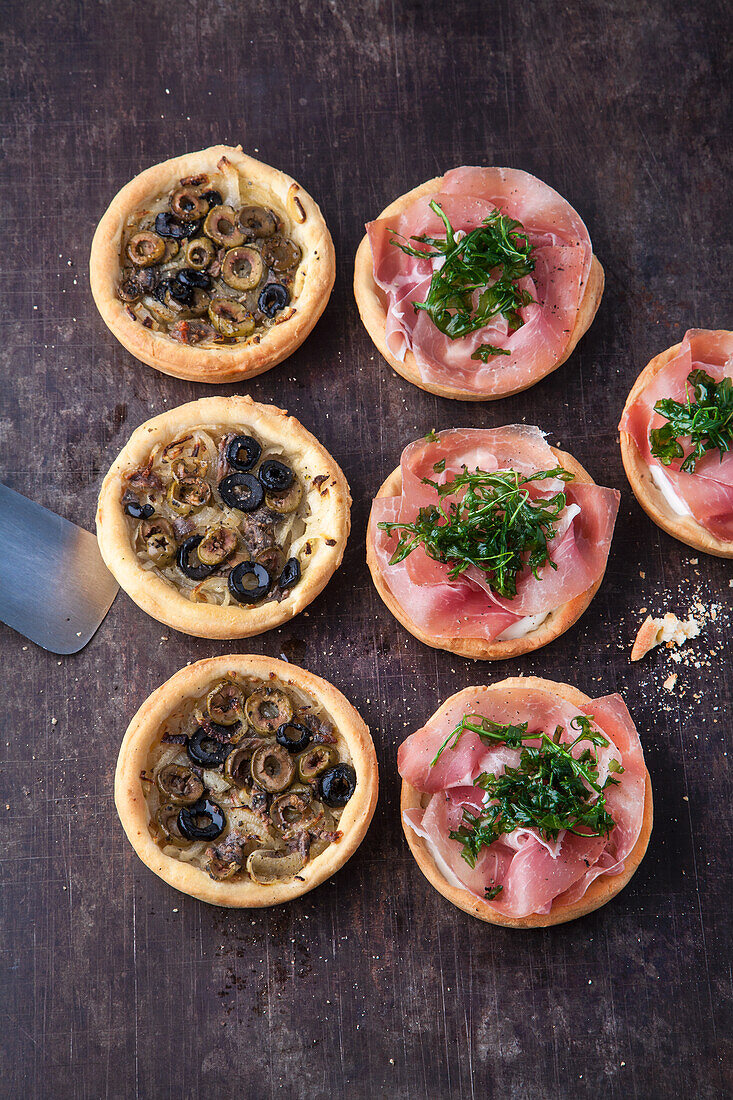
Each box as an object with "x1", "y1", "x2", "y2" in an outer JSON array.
[{"x1": 89, "y1": 145, "x2": 336, "y2": 382}]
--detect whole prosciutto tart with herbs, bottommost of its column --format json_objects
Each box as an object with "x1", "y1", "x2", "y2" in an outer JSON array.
[{"x1": 397, "y1": 677, "x2": 653, "y2": 928}]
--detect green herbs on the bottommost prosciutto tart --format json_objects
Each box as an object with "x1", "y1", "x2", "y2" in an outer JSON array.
[{"x1": 433, "y1": 714, "x2": 624, "y2": 866}]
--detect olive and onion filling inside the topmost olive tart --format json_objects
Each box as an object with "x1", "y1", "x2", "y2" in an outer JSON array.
[{"x1": 116, "y1": 157, "x2": 303, "y2": 345}]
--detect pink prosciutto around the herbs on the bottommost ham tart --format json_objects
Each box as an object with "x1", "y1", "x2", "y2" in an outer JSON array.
[{"x1": 397, "y1": 685, "x2": 646, "y2": 917}]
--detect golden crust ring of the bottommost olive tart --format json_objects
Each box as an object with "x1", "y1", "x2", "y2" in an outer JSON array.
[{"x1": 114, "y1": 653, "x2": 379, "y2": 909}]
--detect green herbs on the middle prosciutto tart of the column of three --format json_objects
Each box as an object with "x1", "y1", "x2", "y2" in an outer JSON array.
[{"x1": 379, "y1": 466, "x2": 573, "y2": 600}]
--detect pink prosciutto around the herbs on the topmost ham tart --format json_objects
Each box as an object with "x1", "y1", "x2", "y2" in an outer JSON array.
[{"x1": 367, "y1": 167, "x2": 593, "y2": 395}]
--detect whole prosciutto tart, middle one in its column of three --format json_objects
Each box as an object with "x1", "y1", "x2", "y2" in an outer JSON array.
[{"x1": 367, "y1": 425, "x2": 620, "y2": 661}]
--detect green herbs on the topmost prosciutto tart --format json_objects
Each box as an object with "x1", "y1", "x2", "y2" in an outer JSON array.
[{"x1": 392, "y1": 200, "x2": 535, "y2": 363}]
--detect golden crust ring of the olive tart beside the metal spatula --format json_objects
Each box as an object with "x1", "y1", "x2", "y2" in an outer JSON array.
[{"x1": 97, "y1": 396, "x2": 351, "y2": 638}]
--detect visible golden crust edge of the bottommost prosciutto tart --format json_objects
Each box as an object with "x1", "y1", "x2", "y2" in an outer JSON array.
[{"x1": 400, "y1": 677, "x2": 654, "y2": 928}]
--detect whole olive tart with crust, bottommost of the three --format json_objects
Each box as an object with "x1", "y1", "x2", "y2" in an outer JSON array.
[{"x1": 114, "y1": 655, "x2": 379, "y2": 909}]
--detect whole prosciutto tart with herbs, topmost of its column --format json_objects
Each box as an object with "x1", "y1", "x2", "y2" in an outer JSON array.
[{"x1": 354, "y1": 167, "x2": 603, "y2": 400}]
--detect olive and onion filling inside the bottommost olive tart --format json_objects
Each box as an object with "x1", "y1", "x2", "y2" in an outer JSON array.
[{"x1": 141, "y1": 672, "x2": 359, "y2": 886}]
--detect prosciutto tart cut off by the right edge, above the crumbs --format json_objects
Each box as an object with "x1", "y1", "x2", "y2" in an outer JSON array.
[{"x1": 619, "y1": 329, "x2": 733, "y2": 558}]
